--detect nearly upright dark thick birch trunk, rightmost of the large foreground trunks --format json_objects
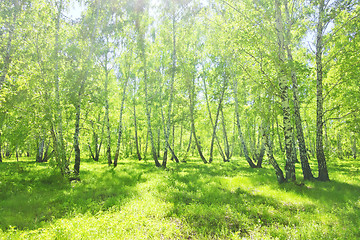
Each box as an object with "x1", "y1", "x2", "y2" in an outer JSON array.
[{"x1": 316, "y1": 0, "x2": 330, "y2": 181}]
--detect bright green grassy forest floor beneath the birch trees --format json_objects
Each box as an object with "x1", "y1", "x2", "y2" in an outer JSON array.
[{"x1": 0, "y1": 158, "x2": 360, "y2": 239}]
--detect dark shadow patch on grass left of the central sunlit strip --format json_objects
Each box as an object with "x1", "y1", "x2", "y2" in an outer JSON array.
[{"x1": 0, "y1": 161, "x2": 146, "y2": 230}]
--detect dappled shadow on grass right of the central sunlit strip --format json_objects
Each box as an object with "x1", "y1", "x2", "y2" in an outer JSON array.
[{"x1": 158, "y1": 159, "x2": 360, "y2": 237}]
